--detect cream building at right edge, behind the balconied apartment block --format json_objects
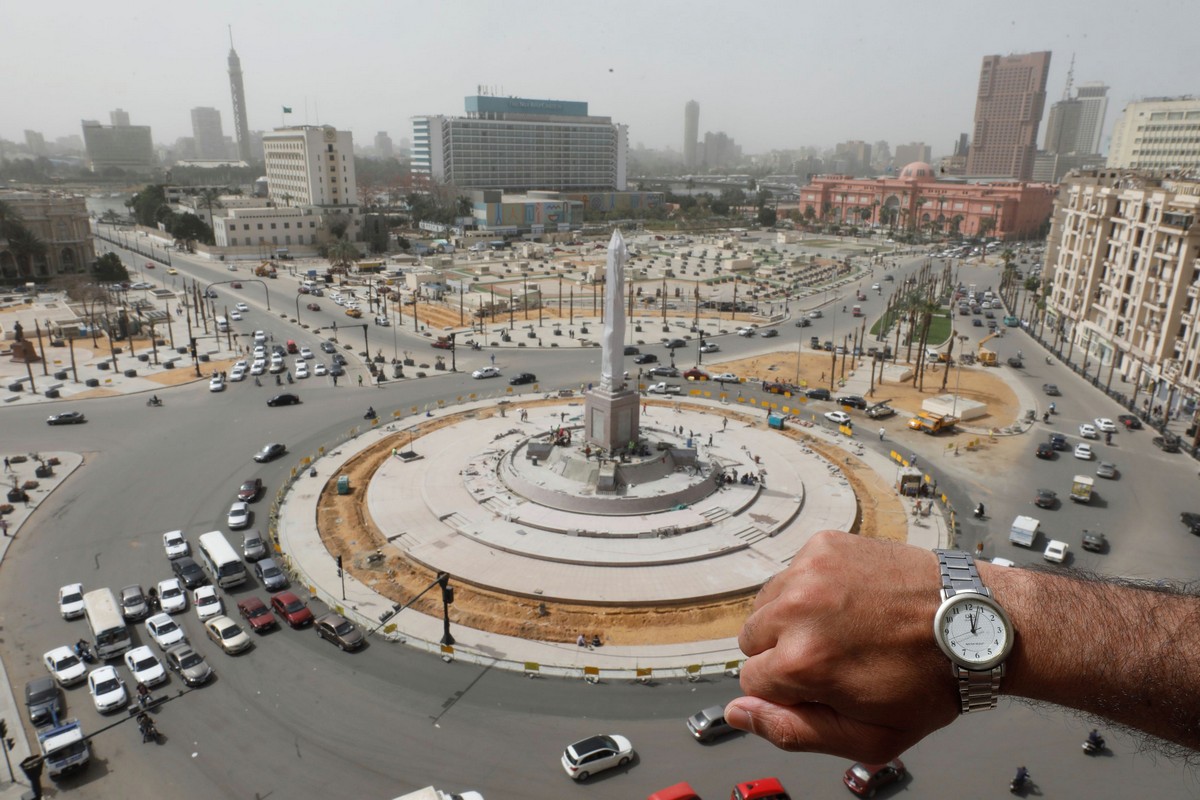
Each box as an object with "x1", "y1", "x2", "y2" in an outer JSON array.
[{"x1": 1108, "y1": 97, "x2": 1200, "y2": 170}]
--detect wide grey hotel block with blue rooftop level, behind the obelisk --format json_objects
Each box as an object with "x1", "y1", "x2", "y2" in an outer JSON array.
[{"x1": 412, "y1": 95, "x2": 629, "y2": 192}]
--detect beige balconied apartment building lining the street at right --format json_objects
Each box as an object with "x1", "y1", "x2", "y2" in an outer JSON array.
[{"x1": 1044, "y1": 172, "x2": 1200, "y2": 411}]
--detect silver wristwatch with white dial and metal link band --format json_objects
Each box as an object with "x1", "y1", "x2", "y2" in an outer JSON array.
[{"x1": 934, "y1": 551, "x2": 1013, "y2": 714}]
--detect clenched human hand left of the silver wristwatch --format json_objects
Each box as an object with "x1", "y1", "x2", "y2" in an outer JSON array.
[{"x1": 725, "y1": 530, "x2": 959, "y2": 764}]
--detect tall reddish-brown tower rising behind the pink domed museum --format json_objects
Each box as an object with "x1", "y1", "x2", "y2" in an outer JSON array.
[{"x1": 967, "y1": 50, "x2": 1050, "y2": 180}]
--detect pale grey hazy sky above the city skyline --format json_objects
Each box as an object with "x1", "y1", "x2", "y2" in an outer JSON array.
[{"x1": 0, "y1": 0, "x2": 1200, "y2": 155}]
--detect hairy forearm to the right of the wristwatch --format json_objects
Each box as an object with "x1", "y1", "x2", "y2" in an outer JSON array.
[{"x1": 979, "y1": 564, "x2": 1200, "y2": 750}]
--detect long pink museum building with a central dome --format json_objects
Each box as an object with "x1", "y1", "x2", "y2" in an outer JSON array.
[{"x1": 799, "y1": 161, "x2": 1057, "y2": 239}]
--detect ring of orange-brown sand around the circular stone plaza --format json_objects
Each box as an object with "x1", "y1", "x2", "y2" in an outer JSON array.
[{"x1": 317, "y1": 398, "x2": 908, "y2": 645}]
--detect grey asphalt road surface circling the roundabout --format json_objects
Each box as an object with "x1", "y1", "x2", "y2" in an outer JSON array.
[{"x1": 0, "y1": 247, "x2": 1196, "y2": 800}]
